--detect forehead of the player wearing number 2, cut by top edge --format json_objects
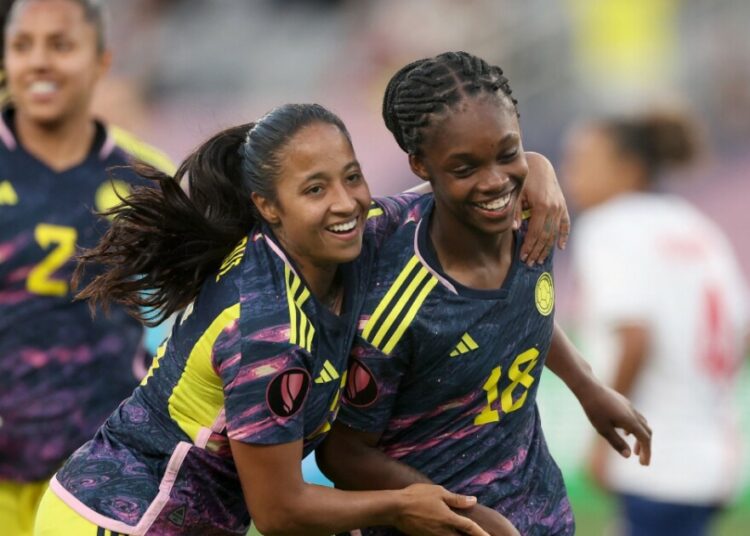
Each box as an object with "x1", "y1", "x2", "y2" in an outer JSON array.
[{"x1": 6, "y1": 0, "x2": 88, "y2": 36}]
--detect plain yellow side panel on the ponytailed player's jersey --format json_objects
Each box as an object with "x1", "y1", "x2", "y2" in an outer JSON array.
[{"x1": 169, "y1": 303, "x2": 240, "y2": 441}]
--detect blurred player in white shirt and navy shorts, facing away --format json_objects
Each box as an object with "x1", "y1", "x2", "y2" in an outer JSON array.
[{"x1": 564, "y1": 114, "x2": 748, "y2": 536}]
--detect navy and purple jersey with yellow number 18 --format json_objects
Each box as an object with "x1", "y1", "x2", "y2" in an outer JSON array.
[{"x1": 339, "y1": 195, "x2": 573, "y2": 535}]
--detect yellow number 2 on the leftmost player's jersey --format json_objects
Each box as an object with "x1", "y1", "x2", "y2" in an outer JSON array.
[{"x1": 26, "y1": 223, "x2": 78, "y2": 296}]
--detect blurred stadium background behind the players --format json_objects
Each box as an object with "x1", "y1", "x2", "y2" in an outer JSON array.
[{"x1": 92, "y1": 0, "x2": 750, "y2": 536}]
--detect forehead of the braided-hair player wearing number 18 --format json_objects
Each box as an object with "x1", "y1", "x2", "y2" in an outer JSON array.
[{"x1": 424, "y1": 95, "x2": 521, "y2": 154}]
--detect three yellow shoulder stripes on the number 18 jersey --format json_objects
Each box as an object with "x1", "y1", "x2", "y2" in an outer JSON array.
[{"x1": 362, "y1": 255, "x2": 438, "y2": 354}]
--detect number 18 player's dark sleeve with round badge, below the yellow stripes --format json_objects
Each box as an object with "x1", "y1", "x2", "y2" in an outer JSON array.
[{"x1": 338, "y1": 336, "x2": 408, "y2": 433}]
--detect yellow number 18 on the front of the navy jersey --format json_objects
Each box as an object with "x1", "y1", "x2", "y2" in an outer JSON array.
[{"x1": 474, "y1": 348, "x2": 539, "y2": 426}]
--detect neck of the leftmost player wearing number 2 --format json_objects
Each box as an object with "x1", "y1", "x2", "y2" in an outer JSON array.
[{"x1": 15, "y1": 112, "x2": 96, "y2": 171}]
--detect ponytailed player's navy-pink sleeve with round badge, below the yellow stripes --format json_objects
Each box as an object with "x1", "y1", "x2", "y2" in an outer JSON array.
[{"x1": 218, "y1": 329, "x2": 312, "y2": 445}]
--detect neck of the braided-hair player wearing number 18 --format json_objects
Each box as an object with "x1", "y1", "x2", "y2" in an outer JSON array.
[{"x1": 430, "y1": 208, "x2": 514, "y2": 290}]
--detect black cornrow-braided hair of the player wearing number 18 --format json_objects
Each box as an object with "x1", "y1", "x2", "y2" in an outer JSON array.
[{"x1": 383, "y1": 52, "x2": 518, "y2": 154}]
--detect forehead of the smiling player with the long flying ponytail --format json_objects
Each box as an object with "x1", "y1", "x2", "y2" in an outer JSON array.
[{"x1": 279, "y1": 122, "x2": 354, "y2": 175}]
